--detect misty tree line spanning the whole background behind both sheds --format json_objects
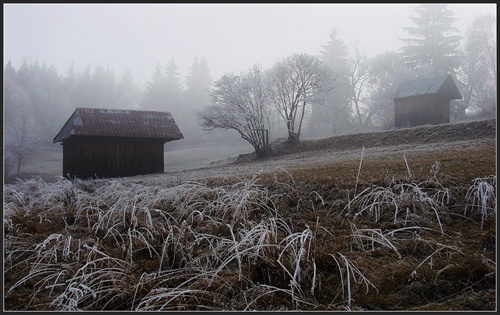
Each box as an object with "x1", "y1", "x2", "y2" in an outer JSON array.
[{"x1": 4, "y1": 4, "x2": 496, "y2": 172}]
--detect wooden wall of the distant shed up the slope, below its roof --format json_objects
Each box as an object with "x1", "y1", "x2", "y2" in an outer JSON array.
[{"x1": 394, "y1": 95, "x2": 450, "y2": 127}]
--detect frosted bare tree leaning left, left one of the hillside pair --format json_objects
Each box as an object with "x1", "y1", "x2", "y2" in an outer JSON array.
[{"x1": 197, "y1": 65, "x2": 271, "y2": 157}]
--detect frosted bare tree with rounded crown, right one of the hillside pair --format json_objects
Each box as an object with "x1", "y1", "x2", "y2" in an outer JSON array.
[{"x1": 269, "y1": 54, "x2": 334, "y2": 144}]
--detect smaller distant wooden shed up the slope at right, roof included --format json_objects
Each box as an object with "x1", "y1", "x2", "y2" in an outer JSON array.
[{"x1": 393, "y1": 74, "x2": 462, "y2": 127}]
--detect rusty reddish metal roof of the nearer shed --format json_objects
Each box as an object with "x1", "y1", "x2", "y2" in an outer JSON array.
[{"x1": 53, "y1": 108, "x2": 184, "y2": 143}]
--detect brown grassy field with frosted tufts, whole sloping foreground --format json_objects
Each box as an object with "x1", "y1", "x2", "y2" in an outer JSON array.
[{"x1": 4, "y1": 120, "x2": 497, "y2": 311}]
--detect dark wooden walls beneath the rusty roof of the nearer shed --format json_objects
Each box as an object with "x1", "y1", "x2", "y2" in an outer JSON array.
[{"x1": 63, "y1": 137, "x2": 164, "y2": 179}]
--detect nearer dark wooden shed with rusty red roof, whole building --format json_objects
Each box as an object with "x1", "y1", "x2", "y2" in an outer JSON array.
[{"x1": 53, "y1": 108, "x2": 184, "y2": 179}]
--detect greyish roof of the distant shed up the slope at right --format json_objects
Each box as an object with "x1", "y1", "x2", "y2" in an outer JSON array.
[{"x1": 393, "y1": 74, "x2": 462, "y2": 100}]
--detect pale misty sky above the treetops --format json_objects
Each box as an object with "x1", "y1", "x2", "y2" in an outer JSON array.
[{"x1": 3, "y1": 3, "x2": 496, "y2": 87}]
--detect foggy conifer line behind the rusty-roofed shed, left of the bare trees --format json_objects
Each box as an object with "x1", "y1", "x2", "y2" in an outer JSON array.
[{"x1": 4, "y1": 57, "x2": 213, "y2": 175}]
